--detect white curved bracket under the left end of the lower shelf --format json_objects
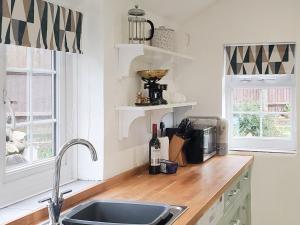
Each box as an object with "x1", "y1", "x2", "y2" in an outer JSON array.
[{"x1": 119, "y1": 110, "x2": 145, "y2": 140}]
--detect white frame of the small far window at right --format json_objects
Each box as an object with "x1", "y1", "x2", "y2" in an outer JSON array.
[{"x1": 223, "y1": 75, "x2": 297, "y2": 153}]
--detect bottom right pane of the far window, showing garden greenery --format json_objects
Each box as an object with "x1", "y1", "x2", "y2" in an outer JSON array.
[{"x1": 263, "y1": 114, "x2": 292, "y2": 137}]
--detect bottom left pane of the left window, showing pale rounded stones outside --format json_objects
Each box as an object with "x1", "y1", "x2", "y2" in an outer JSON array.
[{"x1": 6, "y1": 127, "x2": 30, "y2": 168}]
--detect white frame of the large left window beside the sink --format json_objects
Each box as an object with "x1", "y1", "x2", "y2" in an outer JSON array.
[{"x1": 0, "y1": 44, "x2": 77, "y2": 208}]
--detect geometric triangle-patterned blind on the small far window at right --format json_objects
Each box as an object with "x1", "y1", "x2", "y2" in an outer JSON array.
[{"x1": 225, "y1": 43, "x2": 295, "y2": 75}]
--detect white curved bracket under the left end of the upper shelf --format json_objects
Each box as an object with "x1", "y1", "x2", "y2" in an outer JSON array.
[{"x1": 117, "y1": 45, "x2": 144, "y2": 77}]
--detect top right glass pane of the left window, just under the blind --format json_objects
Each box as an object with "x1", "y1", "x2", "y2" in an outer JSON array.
[{"x1": 32, "y1": 48, "x2": 52, "y2": 70}]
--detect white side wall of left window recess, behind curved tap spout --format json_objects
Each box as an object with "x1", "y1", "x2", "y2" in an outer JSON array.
[{"x1": 77, "y1": 0, "x2": 105, "y2": 180}]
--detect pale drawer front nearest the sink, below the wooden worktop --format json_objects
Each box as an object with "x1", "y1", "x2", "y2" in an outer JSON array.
[{"x1": 197, "y1": 196, "x2": 224, "y2": 225}]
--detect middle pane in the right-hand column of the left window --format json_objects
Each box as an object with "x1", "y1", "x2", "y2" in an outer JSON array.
[{"x1": 32, "y1": 74, "x2": 53, "y2": 120}]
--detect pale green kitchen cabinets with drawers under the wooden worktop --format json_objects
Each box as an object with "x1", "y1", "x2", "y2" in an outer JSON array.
[{"x1": 196, "y1": 168, "x2": 251, "y2": 225}]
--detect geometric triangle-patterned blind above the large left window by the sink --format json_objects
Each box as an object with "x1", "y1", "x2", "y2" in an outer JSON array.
[{"x1": 0, "y1": 0, "x2": 82, "y2": 53}]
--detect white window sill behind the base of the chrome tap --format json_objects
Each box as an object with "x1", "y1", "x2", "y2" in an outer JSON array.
[{"x1": 0, "y1": 181, "x2": 99, "y2": 224}]
